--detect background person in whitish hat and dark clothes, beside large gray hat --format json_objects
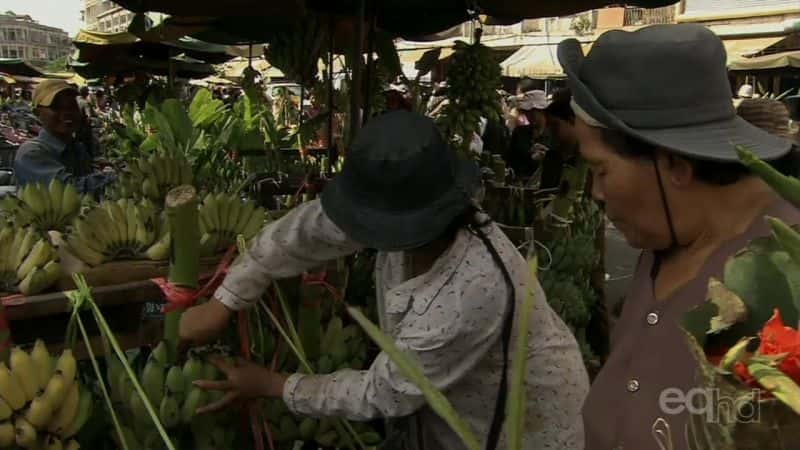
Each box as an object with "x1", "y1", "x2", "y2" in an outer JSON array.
[{"x1": 506, "y1": 90, "x2": 549, "y2": 179}]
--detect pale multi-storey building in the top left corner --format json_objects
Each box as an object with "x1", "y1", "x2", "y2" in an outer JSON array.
[{"x1": 0, "y1": 11, "x2": 72, "y2": 66}]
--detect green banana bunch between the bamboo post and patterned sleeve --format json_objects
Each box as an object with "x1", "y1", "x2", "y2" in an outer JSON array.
[{"x1": 199, "y1": 193, "x2": 267, "y2": 256}]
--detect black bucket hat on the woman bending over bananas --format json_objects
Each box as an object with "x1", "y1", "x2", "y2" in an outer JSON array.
[{"x1": 321, "y1": 111, "x2": 480, "y2": 251}]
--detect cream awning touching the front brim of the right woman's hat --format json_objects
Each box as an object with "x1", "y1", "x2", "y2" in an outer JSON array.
[{"x1": 500, "y1": 42, "x2": 592, "y2": 79}]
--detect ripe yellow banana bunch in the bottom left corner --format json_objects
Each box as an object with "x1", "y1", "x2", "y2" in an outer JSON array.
[{"x1": 0, "y1": 340, "x2": 94, "y2": 450}]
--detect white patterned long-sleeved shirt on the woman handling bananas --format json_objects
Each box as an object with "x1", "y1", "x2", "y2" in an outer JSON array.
[{"x1": 215, "y1": 201, "x2": 589, "y2": 450}]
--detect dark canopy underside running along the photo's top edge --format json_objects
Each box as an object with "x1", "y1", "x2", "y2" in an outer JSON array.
[{"x1": 109, "y1": 0, "x2": 675, "y2": 37}]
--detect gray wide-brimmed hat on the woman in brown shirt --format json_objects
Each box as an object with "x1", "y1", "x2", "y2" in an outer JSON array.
[{"x1": 558, "y1": 24, "x2": 791, "y2": 162}]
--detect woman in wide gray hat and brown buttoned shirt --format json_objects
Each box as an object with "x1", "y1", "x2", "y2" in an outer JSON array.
[{"x1": 558, "y1": 24, "x2": 800, "y2": 450}]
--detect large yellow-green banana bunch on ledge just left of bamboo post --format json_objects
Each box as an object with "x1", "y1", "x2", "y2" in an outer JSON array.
[{"x1": 64, "y1": 198, "x2": 170, "y2": 266}]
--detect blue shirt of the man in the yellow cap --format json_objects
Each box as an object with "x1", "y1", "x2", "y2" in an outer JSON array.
[{"x1": 14, "y1": 129, "x2": 114, "y2": 195}]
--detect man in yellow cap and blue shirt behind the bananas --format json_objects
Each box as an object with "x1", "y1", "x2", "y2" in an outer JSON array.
[{"x1": 14, "y1": 80, "x2": 113, "y2": 195}]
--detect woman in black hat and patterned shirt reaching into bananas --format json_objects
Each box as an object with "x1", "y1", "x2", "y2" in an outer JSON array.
[{"x1": 181, "y1": 111, "x2": 588, "y2": 450}]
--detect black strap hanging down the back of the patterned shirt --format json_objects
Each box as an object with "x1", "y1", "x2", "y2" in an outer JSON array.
[{"x1": 474, "y1": 226, "x2": 517, "y2": 450}]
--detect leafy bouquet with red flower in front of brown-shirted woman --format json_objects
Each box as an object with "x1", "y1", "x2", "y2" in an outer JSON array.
[{"x1": 676, "y1": 148, "x2": 800, "y2": 450}]
